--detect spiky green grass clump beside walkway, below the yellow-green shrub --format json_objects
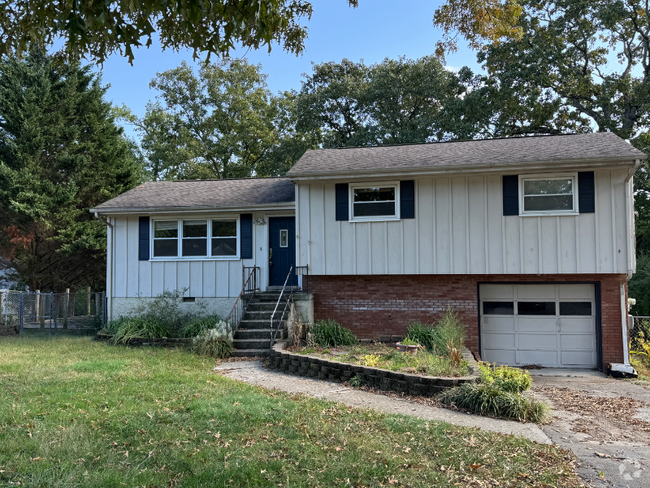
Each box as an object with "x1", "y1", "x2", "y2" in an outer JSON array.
[{"x1": 438, "y1": 382, "x2": 549, "y2": 423}]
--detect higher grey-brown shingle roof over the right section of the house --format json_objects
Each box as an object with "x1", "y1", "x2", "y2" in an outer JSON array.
[{"x1": 287, "y1": 132, "x2": 646, "y2": 178}]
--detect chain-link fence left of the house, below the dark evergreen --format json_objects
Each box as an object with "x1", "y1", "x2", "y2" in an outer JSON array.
[{"x1": 0, "y1": 290, "x2": 106, "y2": 335}]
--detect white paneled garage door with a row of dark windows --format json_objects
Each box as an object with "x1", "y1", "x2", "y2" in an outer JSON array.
[{"x1": 480, "y1": 285, "x2": 598, "y2": 368}]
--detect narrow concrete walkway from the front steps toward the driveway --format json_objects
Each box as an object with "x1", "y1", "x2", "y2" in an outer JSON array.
[{"x1": 214, "y1": 361, "x2": 552, "y2": 444}]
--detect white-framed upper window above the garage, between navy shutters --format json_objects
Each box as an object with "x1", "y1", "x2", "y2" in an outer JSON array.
[{"x1": 519, "y1": 173, "x2": 578, "y2": 215}]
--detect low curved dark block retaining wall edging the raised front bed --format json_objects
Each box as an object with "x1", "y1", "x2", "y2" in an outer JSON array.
[{"x1": 269, "y1": 342, "x2": 477, "y2": 396}]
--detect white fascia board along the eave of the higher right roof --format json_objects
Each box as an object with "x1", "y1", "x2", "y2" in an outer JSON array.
[{"x1": 288, "y1": 158, "x2": 635, "y2": 183}]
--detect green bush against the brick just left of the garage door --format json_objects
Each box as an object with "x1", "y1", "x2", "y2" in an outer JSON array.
[{"x1": 402, "y1": 307, "x2": 465, "y2": 357}]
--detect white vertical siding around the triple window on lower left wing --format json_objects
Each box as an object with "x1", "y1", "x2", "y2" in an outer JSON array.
[{"x1": 107, "y1": 213, "x2": 282, "y2": 298}]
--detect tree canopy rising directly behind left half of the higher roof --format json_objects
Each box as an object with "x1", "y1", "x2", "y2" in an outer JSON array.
[{"x1": 296, "y1": 56, "x2": 466, "y2": 147}]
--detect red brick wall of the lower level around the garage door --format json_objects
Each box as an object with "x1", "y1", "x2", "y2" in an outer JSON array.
[{"x1": 309, "y1": 274, "x2": 627, "y2": 365}]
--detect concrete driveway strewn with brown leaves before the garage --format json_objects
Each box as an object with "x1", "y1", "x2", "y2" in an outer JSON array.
[{"x1": 531, "y1": 370, "x2": 650, "y2": 488}]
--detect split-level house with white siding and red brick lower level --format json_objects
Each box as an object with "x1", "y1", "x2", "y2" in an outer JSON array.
[{"x1": 93, "y1": 133, "x2": 645, "y2": 369}]
